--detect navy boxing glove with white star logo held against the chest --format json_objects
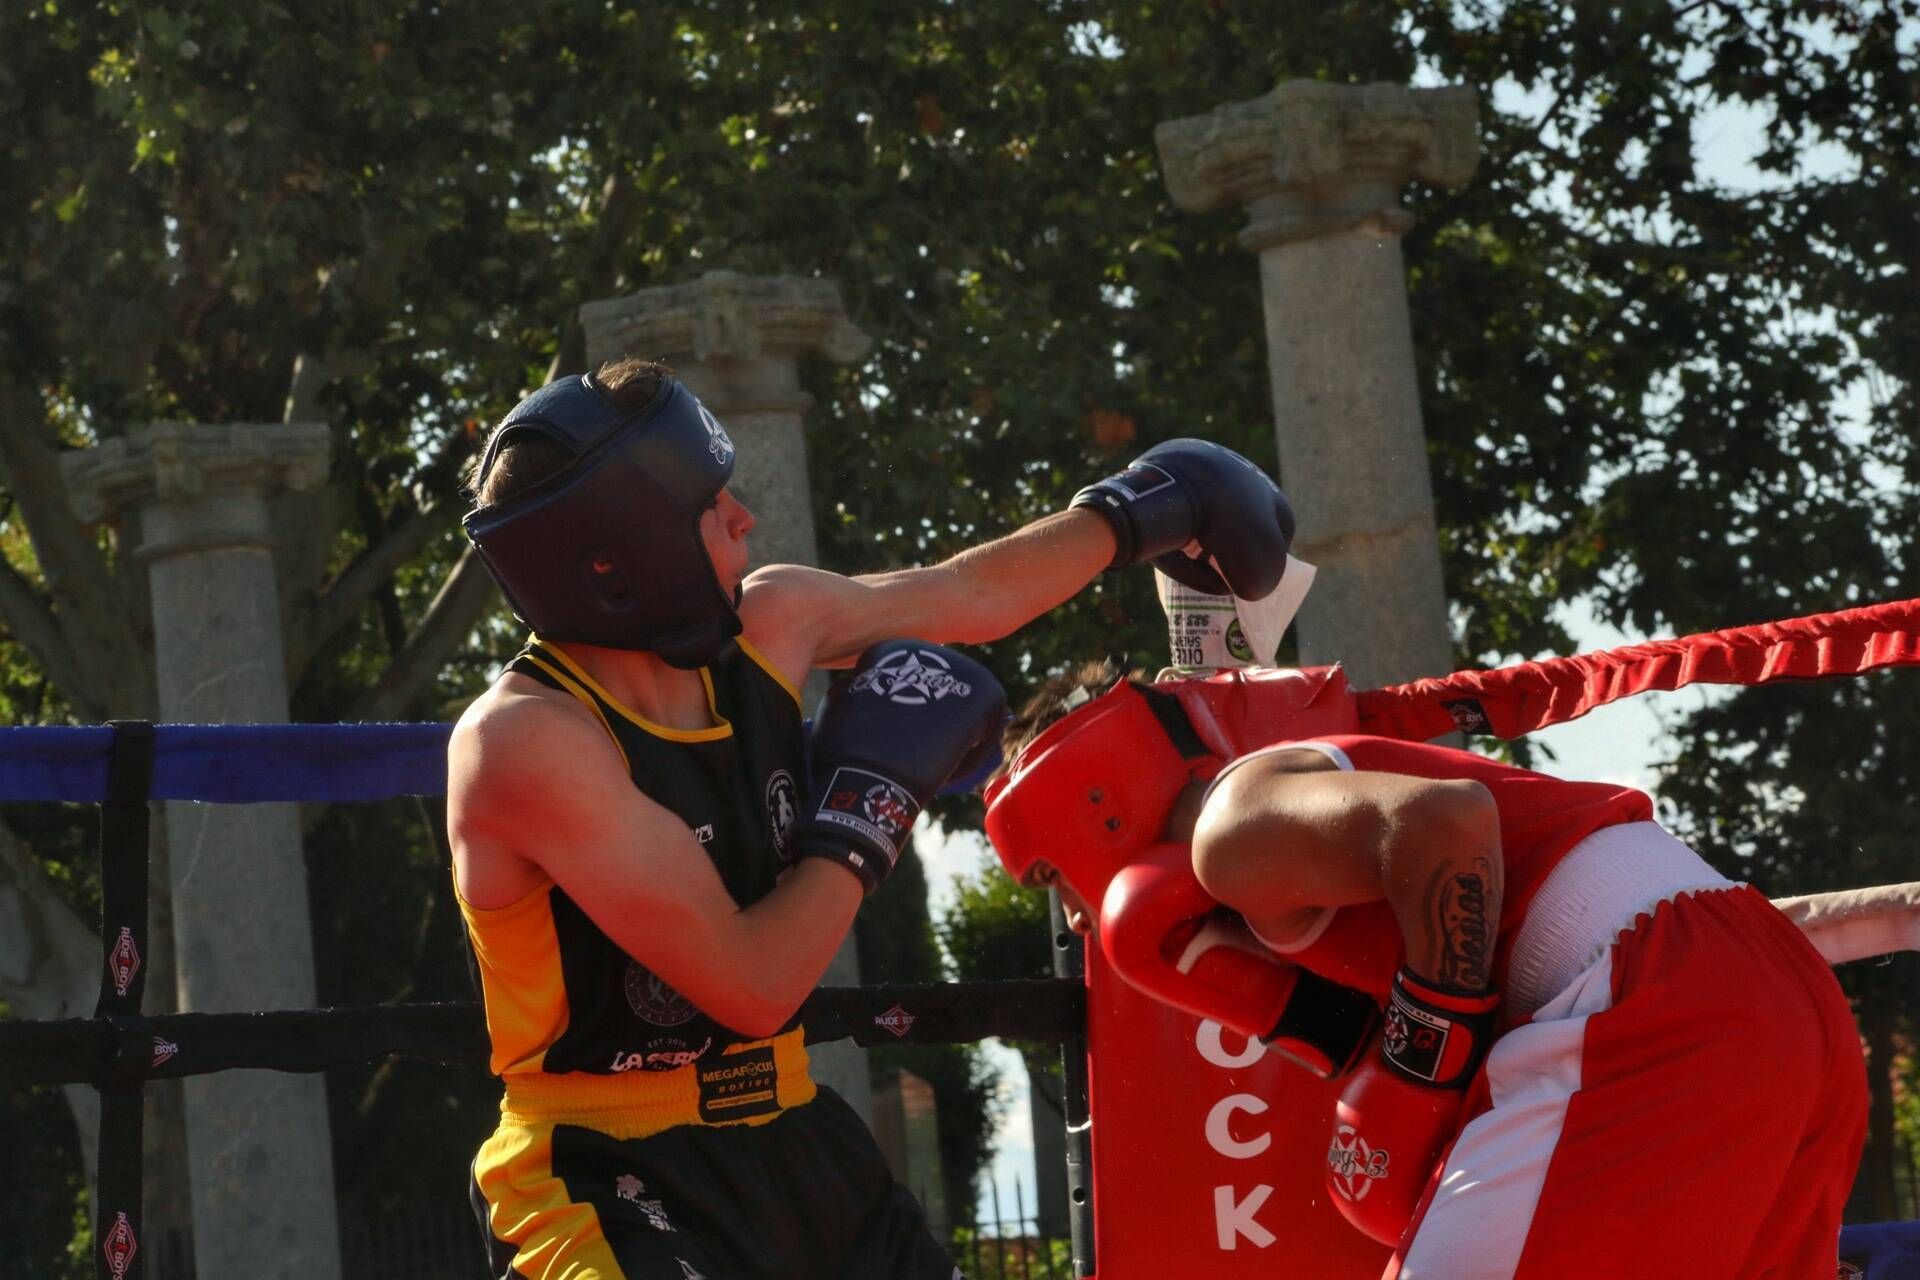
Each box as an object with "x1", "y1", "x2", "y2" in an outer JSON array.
[{"x1": 795, "y1": 639, "x2": 1006, "y2": 892}]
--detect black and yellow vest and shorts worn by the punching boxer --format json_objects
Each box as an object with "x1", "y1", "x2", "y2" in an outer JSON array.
[{"x1": 461, "y1": 637, "x2": 958, "y2": 1280}]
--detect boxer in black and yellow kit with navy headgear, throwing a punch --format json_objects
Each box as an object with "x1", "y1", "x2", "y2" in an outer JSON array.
[{"x1": 447, "y1": 359, "x2": 1221, "y2": 1280}]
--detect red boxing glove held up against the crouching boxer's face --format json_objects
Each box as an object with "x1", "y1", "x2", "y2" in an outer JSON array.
[{"x1": 1098, "y1": 844, "x2": 1379, "y2": 1079}]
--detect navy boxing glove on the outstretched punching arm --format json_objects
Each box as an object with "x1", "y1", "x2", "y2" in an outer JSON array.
[{"x1": 1069, "y1": 439, "x2": 1294, "y2": 601}]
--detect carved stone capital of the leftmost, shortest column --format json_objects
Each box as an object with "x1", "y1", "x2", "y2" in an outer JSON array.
[{"x1": 60, "y1": 422, "x2": 332, "y2": 558}]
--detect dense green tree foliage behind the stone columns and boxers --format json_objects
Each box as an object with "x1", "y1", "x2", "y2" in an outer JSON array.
[{"x1": 0, "y1": 0, "x2": 1920, "y2": 1266}]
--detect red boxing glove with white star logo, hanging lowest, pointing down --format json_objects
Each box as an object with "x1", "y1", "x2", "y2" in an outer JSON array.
[{"x1": 1327, "y1": 969, "x2": 1500, "y2": 1245}]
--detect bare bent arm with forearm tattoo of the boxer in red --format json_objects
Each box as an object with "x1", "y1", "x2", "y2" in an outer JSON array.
[{"x1": 1192, "y1": 750, "x2": 1505, "y2": 990}]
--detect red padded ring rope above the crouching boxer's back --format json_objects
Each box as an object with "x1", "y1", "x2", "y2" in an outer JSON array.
[{"x1": 1354, "y1": 599, "x2": 1920, "y2": 741}]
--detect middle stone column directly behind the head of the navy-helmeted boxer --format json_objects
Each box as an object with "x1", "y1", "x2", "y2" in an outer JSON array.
[{"x1": 580, "y1": 271, "x2": 874, "y2": 1121}]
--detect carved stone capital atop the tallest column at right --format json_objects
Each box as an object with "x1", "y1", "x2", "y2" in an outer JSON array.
[{"x1": 1154, "y1": 81, "x2": 1480, "y2": 251}]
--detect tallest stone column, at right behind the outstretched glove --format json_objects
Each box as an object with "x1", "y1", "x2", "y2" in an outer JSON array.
[{"x1": 1154, "y1": 81, "x2": 1480, "y2": 689}]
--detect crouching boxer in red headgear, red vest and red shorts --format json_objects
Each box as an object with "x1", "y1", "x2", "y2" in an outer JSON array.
[{"x1": 989, "y1": 672, "x2": 1866, "y2": 1280}]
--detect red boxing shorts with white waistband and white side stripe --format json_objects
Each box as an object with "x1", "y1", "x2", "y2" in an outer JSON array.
[{"x1": 1386, "y1": 823, "x2": 1866, "y2": 1280}]
